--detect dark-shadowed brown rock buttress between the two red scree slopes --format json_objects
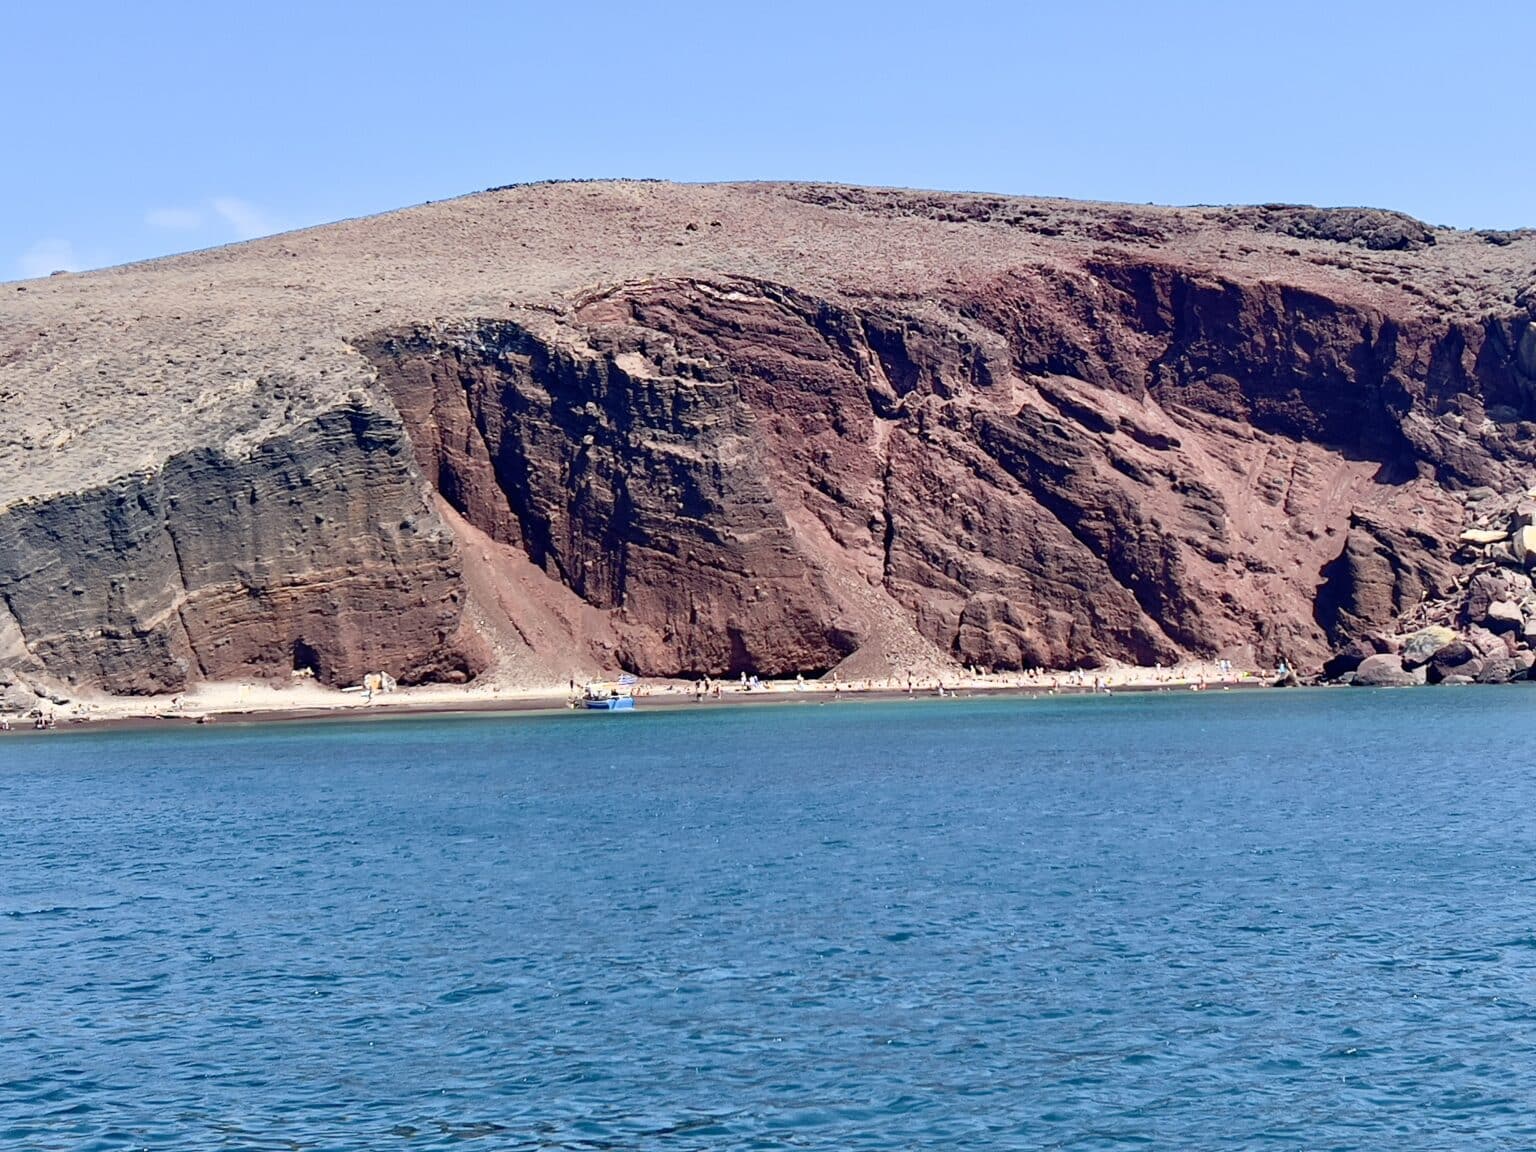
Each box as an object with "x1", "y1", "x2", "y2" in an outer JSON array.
[{"x1": 370, "y1": 324, "x2": 856, "y2": 674}]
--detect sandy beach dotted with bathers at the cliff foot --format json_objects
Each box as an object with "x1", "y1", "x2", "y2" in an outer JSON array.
[{"x1": 0, "y1": 662, "x2": 1273, "y2": 734}]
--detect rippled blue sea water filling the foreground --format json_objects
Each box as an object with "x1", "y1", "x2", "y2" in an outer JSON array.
[{"x1": 0, "y1": 688, "x2": 1536, "y2": 1149}]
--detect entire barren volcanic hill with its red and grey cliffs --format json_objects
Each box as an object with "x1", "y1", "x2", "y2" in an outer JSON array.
[{"x1": 0, "y1": 181, "x2": 1536, "y2": 694}]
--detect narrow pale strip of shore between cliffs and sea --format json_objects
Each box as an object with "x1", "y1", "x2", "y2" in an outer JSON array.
[{"x1": 0, "y1": 668, "x2": 1275, "y2": 739}]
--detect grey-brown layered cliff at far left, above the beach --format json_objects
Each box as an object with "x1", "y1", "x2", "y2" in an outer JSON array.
[{"x1": 0, "y1": 409, "x2": 473, "y2": 693}]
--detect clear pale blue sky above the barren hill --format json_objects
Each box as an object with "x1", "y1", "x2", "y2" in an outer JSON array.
[{"x1": 0, "y1": 0, "x2": 1536, "y2": 278}]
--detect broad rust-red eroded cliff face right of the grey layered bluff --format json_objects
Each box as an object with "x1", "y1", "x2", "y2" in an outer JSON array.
[{"x1": 369, "y1": 261, "x2": 1536, "y2": 674}]
